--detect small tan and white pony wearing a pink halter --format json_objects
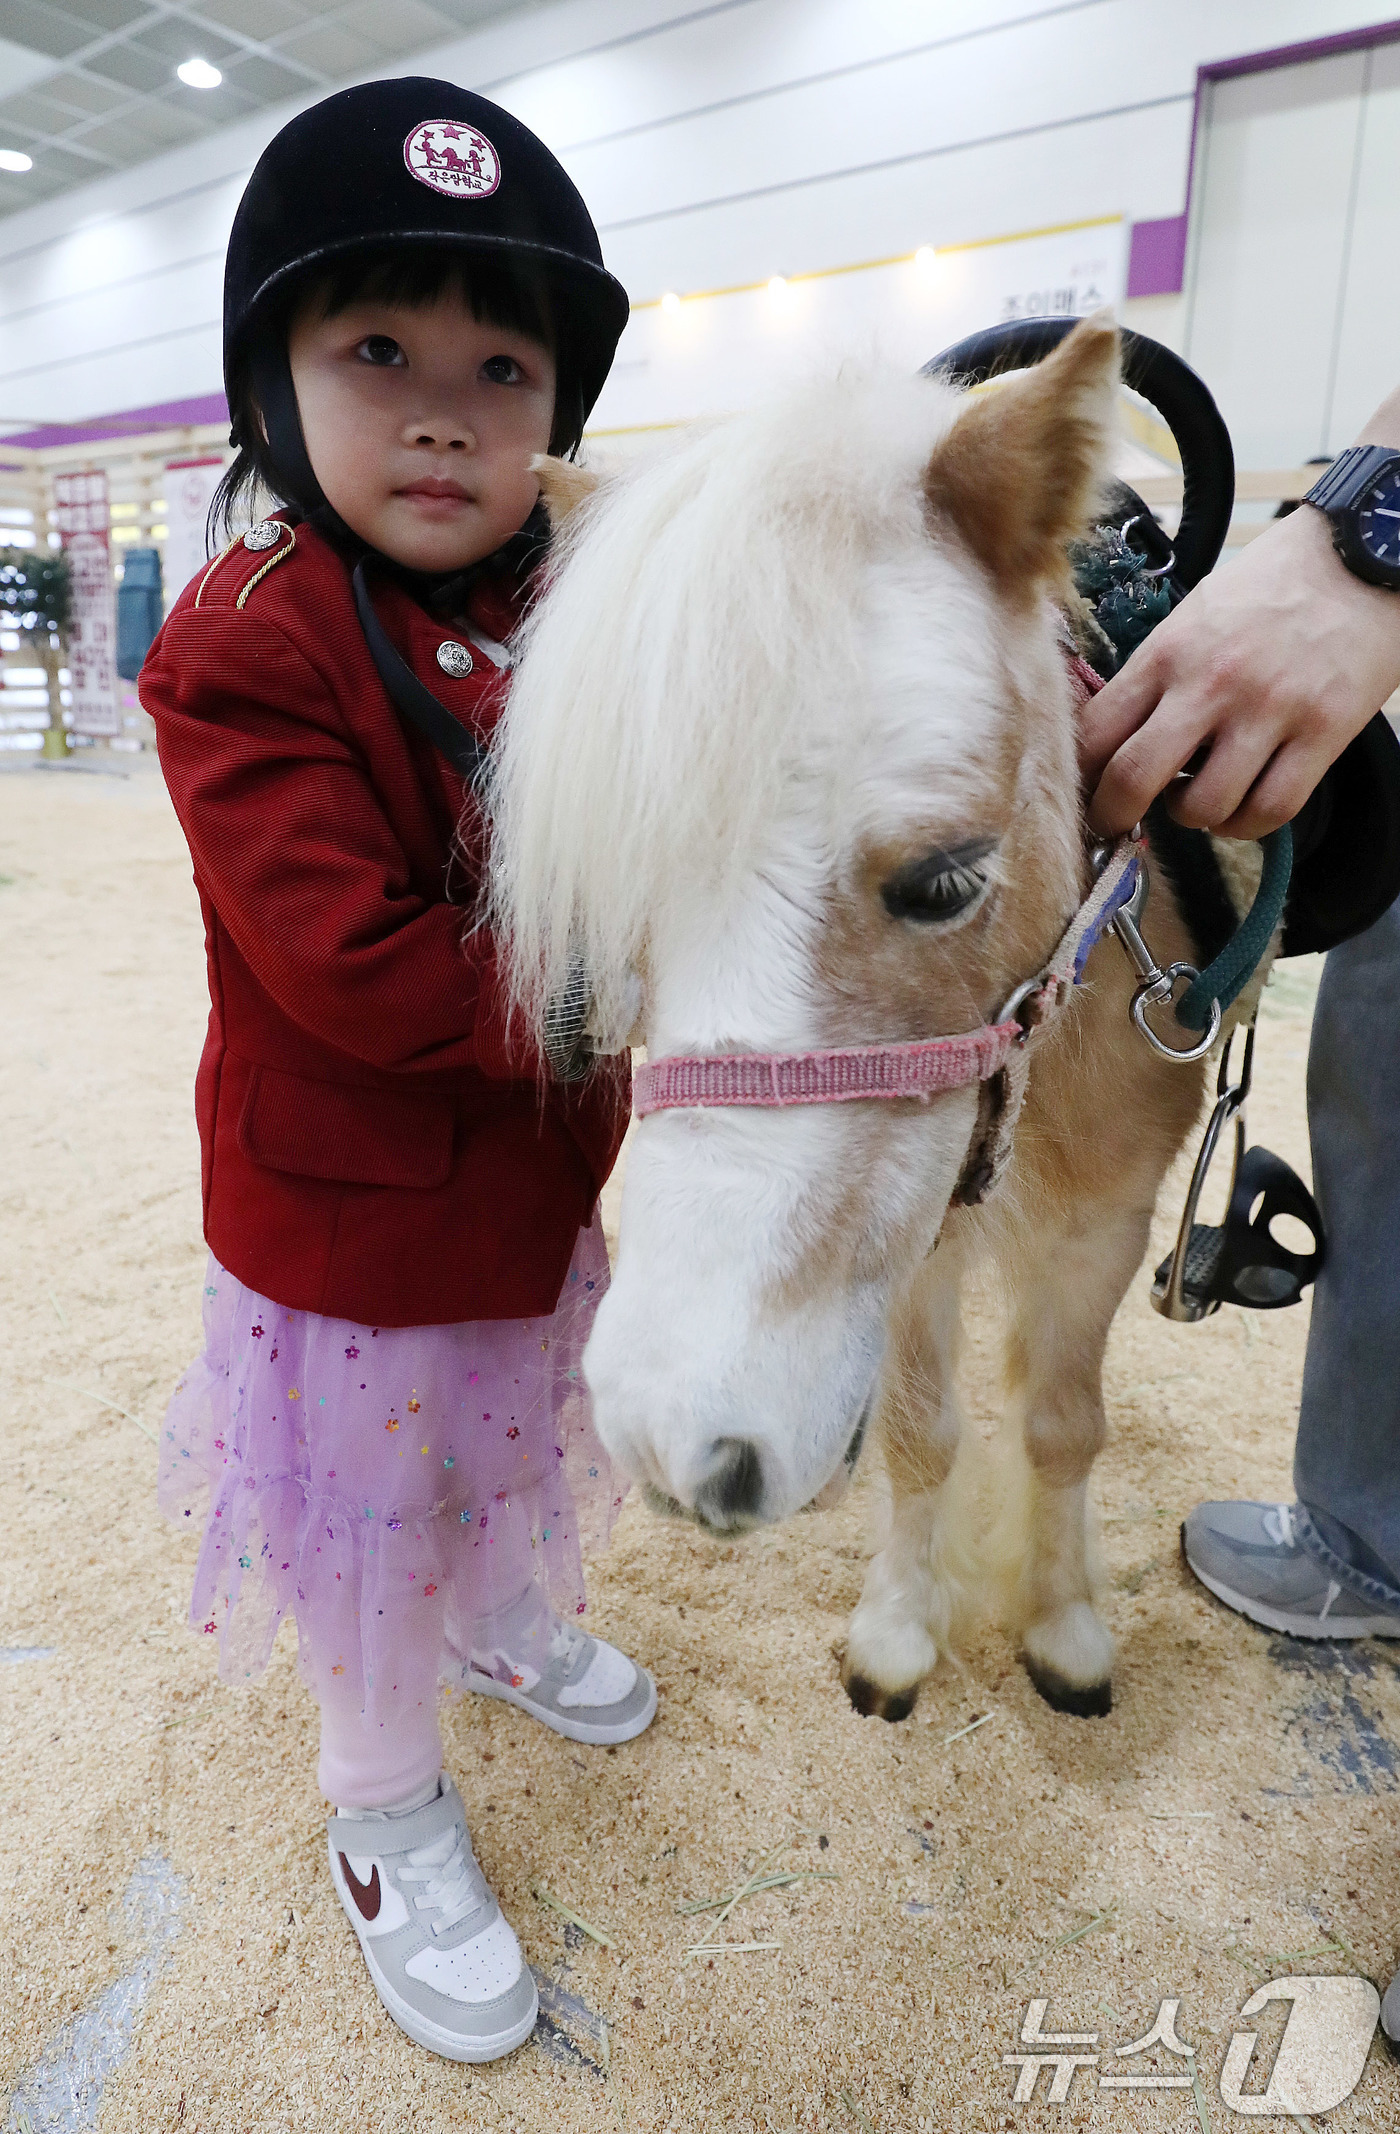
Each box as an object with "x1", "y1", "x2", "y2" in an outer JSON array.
[{"x1": 493, "y1": 318, "x2": 1202, "y2": 1718}]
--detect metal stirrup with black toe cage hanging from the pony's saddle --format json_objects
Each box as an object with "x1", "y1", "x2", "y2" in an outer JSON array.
[{"x1": 1152, "y1": 1022, "x2": 1325, "y2": 1323}]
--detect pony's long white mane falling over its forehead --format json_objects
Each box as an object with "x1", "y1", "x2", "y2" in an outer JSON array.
[{"x1": 489, "y1": 371, "x2": 958, "y2": 1039}]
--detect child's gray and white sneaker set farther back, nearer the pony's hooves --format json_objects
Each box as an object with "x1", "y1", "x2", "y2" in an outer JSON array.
[{"x1": 448, "y1": 1586, "x2": 657, "y2": 1746}]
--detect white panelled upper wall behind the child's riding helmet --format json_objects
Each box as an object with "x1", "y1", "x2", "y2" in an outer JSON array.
[{"x1": 0, "y1": 0, "x2": 1391, "y2": 427}]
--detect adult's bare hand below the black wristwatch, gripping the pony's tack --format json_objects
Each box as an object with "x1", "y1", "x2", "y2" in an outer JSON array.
[{"x1": 1080, "y1": 463, "x2": 1400, "y2": 837}]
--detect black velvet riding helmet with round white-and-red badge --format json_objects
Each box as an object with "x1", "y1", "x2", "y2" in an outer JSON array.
[{"x1": 224, "y1": 77, "x2": 627, "y2": 512}]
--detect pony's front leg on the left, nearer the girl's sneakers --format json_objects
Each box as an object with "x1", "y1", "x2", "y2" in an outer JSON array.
[{"x1": 841, "y1": 1238, "x2": 971, "y2": 1720}]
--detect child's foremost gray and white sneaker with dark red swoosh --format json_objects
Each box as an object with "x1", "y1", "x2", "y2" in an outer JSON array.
[{"x1": 327, "y1": 1771, "x2": 540, "y2": 2061}]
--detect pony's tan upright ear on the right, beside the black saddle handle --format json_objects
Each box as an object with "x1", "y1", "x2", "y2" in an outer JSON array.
[{"x1": 924, "y1": 312, "x2": 1118, "y2": 591}]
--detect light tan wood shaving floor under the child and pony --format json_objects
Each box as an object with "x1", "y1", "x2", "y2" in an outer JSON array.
[{"x1": 0, "y1": 758, "x2": 1400, "y2": 2134}]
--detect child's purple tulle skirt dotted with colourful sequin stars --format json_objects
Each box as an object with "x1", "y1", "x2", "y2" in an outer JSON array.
[{"x1": 160, "y1": 1219, "x2": 621, "y2": 1724}]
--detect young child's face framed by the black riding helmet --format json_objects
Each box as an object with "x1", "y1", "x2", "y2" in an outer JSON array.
[{"x1": 288, "y1": 290, "x2": 555, "y2": 570}]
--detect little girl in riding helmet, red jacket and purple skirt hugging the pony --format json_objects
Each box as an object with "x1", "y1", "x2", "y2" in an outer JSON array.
[{"x1": 143, "y1": 81, "x2": 655, "y2": 2059}]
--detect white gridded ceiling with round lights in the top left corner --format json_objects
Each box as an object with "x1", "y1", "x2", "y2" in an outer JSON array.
[{"x1": 0, "y1": 0, "x2": 531, "y2": 216}]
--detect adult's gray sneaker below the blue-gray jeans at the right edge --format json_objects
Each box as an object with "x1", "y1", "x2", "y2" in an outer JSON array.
[{"x1": 1182, "y1": 1502, "x2": 1400, "y2": 1639}]
